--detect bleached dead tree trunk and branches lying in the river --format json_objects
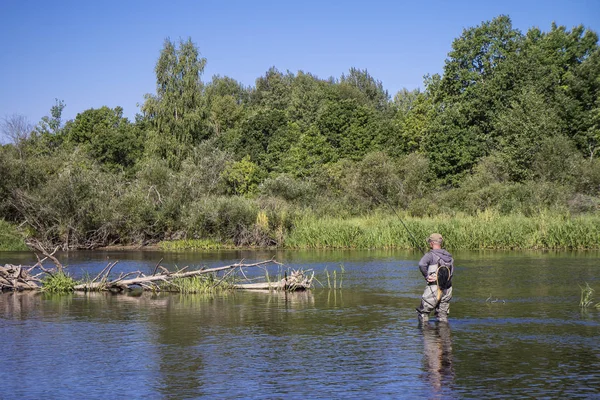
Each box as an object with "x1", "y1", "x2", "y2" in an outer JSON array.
[{"x1": 0, "y1": 243, "x2": 314, "y2": 292}]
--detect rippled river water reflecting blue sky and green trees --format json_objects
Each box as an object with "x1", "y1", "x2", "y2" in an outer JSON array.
[{"x1": 0, "y1": 251, "x2": 600, "y2": 399}]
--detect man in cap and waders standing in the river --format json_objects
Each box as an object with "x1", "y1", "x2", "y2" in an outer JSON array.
[{"x1": 417, "y1": 233, "x2": 454, "y2": 323}]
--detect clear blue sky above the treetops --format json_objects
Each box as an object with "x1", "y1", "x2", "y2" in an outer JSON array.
[{"x1": 0, "y1": 0, "x2": 600, "y2": 124}]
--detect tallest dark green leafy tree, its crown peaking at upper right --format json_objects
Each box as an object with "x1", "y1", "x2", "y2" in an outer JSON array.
[{"x1": 422, "y1": 16, "x2": 522, "y2": 184}]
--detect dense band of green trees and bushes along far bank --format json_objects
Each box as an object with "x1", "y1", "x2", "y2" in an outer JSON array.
[{"x1": 0, "y1": 16, "x2": 600, "y2": 248}]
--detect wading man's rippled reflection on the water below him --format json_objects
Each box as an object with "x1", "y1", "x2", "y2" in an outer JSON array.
[{"x1": 423, "y1": 323, "x2": 454, "y2": 395}]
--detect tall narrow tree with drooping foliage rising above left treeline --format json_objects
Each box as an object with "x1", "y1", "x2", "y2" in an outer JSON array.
[{"x1": 142, "y1": 38, "x2": 208, "y2": 166}]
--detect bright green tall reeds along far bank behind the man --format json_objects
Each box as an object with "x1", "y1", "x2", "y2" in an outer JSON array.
[{"x1": 285, "y1": 212, "x2": 600, "y2": 249}]
